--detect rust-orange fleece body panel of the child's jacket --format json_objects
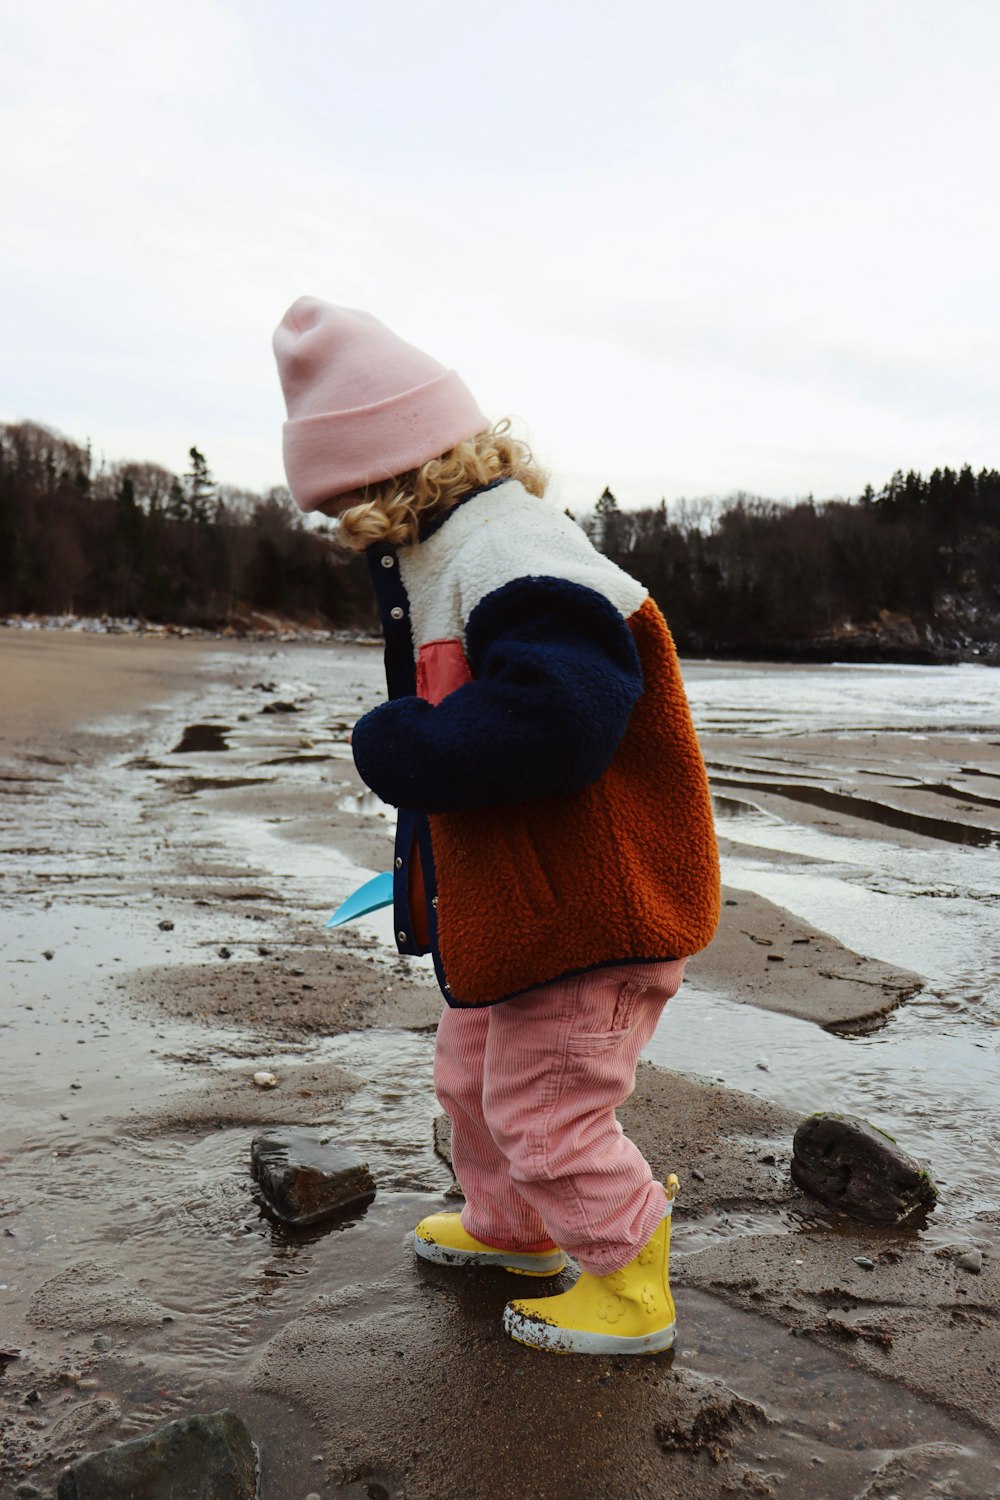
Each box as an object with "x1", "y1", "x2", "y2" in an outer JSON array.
[{"x1": 430, "y1": 599, "x2": 720, "y2": 1005}]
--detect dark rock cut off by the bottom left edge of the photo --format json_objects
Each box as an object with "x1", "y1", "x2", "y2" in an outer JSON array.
[{"x1": 58, "y1": 1412, "x2": 258, "y2": 1500}]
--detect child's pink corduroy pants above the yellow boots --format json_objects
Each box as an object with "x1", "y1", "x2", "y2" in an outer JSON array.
[{"x1": 435, "y1": 960, "x2": 684, "y2": 1277}]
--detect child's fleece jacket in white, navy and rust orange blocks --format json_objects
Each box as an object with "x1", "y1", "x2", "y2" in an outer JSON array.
[{"x1": 352, "y1": 480, "x2": 720, "y2": 1007}]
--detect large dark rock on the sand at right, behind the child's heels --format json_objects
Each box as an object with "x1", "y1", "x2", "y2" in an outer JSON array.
[{"x1": 792, "y1": 1113, "x2": 937, "y2": 1224}]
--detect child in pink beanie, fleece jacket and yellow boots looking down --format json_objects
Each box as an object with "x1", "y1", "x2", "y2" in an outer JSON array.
[{"x1": 274, "y1": 297, "x2": 720, "y2": 1355}]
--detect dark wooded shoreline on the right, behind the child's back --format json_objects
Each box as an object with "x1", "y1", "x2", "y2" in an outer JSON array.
[{"x1": 583, "y1": 467, "x2": 1000, "y2": 665}]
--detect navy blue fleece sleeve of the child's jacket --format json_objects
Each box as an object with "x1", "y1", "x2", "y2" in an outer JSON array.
[{"x1": 352, "y1": 578, "x2": 643, "y2": 813}]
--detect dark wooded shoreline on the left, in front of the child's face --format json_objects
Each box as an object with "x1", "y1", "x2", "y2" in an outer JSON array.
[{"x1": 0, "y1": 422, "x2": 376, "y2": 629}]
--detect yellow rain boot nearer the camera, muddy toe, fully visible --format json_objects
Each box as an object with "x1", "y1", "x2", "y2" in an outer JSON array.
[{"x1": 504, "y1": 1175, "x2": 679, "y2": 1355}]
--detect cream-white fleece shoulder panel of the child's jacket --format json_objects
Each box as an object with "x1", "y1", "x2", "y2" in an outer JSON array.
[{"x1": 399, "y1": 480, "x2": 646, "y2": 651}]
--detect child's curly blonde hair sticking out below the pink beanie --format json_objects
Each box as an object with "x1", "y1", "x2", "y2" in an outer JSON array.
[{"x1": 328, "y1": 417, "x2": 549, "y2": 552}]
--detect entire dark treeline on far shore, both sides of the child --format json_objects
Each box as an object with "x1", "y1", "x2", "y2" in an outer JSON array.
[{"x1": 0, "y1": 423, "x2": 1000, "y2": 665}]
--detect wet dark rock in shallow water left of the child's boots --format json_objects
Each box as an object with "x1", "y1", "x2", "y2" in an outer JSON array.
[{"x1": 250, "y1": 1125, "x2": 375, "y2": 1226}]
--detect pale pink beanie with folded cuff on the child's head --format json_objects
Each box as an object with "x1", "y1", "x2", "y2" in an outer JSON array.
[{"x1": 274, "y1": 297, "x2": 489, "y2": 510}]
